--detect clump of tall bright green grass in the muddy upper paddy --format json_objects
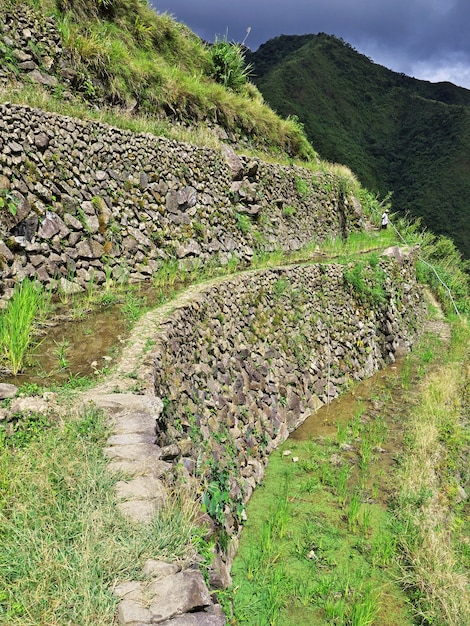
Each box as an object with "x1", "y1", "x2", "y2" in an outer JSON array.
[{"x1": 0, "y1": 278, "x2": 49, "y2": 375}]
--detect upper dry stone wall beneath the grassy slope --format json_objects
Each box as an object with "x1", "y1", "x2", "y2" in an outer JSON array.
[{"x1": 0, "y1": 104, "x2": 360, "y2": 300}]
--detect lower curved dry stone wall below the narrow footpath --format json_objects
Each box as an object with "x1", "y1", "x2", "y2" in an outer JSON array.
[{"x1": 154, "y1": 249, "x2": 423, "y2": 560}]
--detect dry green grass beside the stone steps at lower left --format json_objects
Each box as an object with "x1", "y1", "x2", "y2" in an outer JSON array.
[{"x1": 0, "y1": 408, "x2": 206, "y2": 626}]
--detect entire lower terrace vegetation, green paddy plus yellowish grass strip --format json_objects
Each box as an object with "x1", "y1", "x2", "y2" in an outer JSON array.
[{"x1": 221, "y1": 321, "x2": 470, "y2": 626}]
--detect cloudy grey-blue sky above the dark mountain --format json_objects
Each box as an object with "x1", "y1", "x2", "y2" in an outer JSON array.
[{"x1": 150, "y1": 0, "x2": 470, "y2": 89}]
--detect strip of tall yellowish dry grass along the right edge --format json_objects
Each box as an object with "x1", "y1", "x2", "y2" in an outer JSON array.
[{"x1": 396, "y1": 320, "x2": 470, "y2": 626}]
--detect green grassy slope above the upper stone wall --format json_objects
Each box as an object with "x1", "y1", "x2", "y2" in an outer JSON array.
[{"x1": 0, "y1": 0, "x2": 315, "y2": 160}]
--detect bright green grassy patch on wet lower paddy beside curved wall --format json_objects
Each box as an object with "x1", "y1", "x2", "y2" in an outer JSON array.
[{"x1": 224, "y1": 429, "x2": 413, "y2": 626}]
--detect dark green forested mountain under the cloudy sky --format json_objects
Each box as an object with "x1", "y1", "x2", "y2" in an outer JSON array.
[{"x1": 246, "y1": 33, "x2": 470, "y2": 258}]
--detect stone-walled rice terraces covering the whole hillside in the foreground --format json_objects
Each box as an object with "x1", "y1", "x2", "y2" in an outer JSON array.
[{"x1": 0, "y1": 0, "x2": 470, "y2": 626}]
